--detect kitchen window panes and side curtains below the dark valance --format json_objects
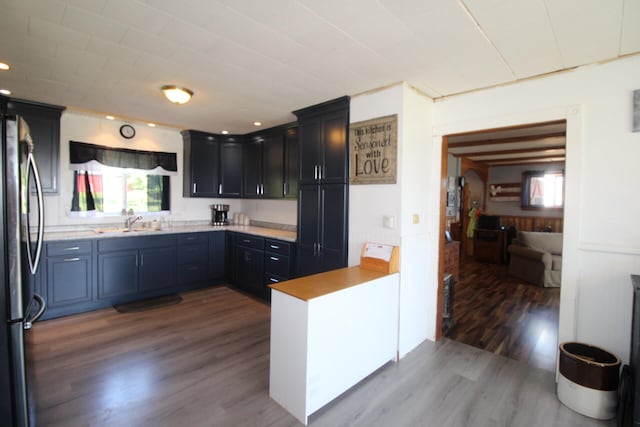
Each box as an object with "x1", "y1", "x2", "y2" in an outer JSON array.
[{"x1": 71, "y1": 167, "x2": 171, "y2": 214}]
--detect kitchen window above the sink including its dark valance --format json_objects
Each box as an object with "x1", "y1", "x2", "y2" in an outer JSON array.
[{"x1": 69, "y1": 141, "x2": 177, "y2": 215}]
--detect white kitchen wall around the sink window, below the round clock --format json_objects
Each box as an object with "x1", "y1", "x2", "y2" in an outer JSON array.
[{"x1": 45, "y1": 111, "x2": 297, "y2": 227}]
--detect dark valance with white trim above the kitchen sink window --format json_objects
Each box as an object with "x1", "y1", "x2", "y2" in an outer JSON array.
[{"x1": 69, "y1": 141, "x2": 178, "y2": 175}]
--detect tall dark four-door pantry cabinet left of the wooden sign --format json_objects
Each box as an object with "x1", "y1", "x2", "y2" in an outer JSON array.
[{"x1": 293, "y1": 97, "x2": 349, "y2": 277}]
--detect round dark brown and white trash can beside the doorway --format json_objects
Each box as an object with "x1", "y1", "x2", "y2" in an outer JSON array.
[{"x1": 557, "y1": 342, "x2": 620, "y2": 420}]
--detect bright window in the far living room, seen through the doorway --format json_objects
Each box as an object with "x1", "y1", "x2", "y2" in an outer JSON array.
[{"x1": 521, "y1": 171, "x2": 564, "y2": 209}]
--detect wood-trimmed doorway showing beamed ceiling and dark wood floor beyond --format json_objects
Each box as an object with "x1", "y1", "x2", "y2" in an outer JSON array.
[{"x1": 439, "y1": 120, "x2": 566, "y2": 370}]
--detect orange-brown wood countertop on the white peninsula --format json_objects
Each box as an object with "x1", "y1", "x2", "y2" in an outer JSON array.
[{"x1": 269, "y1": 266, "x2": 395, "y2": 301}]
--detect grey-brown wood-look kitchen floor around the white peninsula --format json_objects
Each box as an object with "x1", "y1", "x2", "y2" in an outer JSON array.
[{"x1": 29, "y1": 286, "x2": 613, "y2": 427}]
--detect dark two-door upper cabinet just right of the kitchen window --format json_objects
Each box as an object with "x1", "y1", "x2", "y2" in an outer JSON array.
[{"x1": 182, "y1": 130, "x2": 242, "y2": 197}]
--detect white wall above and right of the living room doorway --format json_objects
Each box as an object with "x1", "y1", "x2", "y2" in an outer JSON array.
[{"x1": 428, "y1": 56, "x2": 640, "y2": 362}]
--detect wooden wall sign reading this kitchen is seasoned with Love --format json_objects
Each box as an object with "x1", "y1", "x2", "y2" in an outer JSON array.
[{"x1": 349, "y1": 114, "x2": 398, "y2": 184}]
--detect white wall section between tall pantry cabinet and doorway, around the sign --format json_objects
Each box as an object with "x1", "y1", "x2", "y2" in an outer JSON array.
[{"x1": 349, "y1": 84, "x2": 440, "y2": 357}]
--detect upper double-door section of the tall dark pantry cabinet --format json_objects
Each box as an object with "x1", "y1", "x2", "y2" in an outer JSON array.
[{"x1": 293, "y1": 97, "x2": 349, "y2": 185}]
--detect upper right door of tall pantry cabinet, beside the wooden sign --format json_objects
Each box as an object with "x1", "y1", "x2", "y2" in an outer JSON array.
[{"x1": 320, "y1": 111, "x2": 348, "y2": 184}]
